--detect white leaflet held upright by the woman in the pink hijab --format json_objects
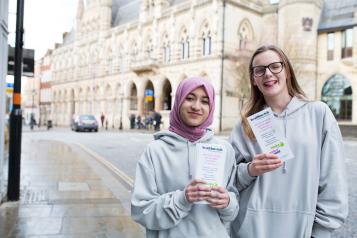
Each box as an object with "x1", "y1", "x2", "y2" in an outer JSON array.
[{"x1": 195, "y1": 143, "x2": 226, "y2": 186}]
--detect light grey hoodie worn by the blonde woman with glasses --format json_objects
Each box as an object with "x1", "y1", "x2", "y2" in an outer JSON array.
[{"x1": 230, "y1": 97, "x2": 348, "y2": 238}]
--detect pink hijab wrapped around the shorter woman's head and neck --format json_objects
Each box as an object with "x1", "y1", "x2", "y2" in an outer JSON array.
[{"x1": 169, "y1": 77, "x2": 214, "y2": 142}]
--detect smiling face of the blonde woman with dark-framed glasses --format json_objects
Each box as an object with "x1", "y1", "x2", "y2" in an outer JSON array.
[{"x1": 252, "y1": 50, "x2": 289, "y2": 99}]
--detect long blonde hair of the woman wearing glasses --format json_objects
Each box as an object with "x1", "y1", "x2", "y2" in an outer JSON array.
[{"x1": 241, "y1": 45, "x2": 306, "y2": 140}]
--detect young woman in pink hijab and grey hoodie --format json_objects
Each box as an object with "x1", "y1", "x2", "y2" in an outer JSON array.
[{"x1": 131, "y1": 77, "x2": 238, "y2": 237}]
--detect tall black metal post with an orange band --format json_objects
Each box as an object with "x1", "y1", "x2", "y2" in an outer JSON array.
[{"x1": 7, "y1": 0, "x2": 24, "y2": 201}]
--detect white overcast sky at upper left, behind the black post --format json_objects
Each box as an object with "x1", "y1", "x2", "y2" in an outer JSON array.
[{"x1": 8, "y1": 0, "x2": 78, "y2": 59}]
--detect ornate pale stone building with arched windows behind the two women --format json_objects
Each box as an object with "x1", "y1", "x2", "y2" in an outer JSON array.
[{"x1": 47, "y1": 0, "x2": 357, "y2": 130}]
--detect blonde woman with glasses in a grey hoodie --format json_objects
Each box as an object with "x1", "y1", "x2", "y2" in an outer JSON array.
[{"x1": 230, "y1": 46, "x2": 348, "y2": 238}]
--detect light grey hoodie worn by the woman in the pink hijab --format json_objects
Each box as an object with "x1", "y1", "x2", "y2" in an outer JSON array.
[{"x1": 131, "y1": 130, "x2": 238, "y2": 238}]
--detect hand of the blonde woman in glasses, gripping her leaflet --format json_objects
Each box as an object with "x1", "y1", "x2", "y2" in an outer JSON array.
[{"x1": 248, "y1": 153, "x2": 283, "y2": 176}]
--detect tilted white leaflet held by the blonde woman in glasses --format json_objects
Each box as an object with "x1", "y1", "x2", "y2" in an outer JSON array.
[{"x1": 248, "y1": 107, "x2": 294, "y2": 161}]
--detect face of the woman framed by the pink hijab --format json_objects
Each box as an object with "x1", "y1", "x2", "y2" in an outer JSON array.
[{"x1": 180, "y1": 87, "x2": 209, "y2": 127}]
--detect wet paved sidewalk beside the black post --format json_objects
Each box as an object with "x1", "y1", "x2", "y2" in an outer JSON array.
[{"x1": 0, "y1": 139, "x2": 144, "y2": 238}]
